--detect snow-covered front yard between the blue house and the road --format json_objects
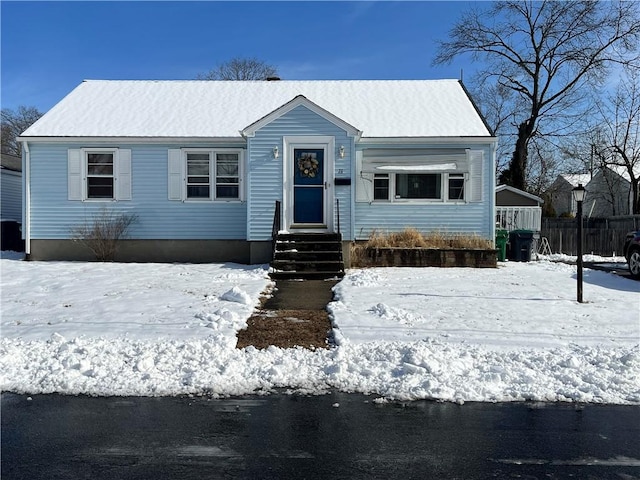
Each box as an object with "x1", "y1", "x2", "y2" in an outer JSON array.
[{"x1": 0, "y1": 252, "x2": 640, "y2": 404}]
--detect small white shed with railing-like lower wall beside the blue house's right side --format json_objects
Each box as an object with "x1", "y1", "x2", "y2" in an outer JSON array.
[{"x1": 496, "y1": 185, "x2": 544, "y2": 232}]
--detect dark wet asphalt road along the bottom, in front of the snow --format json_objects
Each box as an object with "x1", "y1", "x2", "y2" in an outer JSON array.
[{"x1": 1, "y1": 393, "x2": 640, "y2": 480}]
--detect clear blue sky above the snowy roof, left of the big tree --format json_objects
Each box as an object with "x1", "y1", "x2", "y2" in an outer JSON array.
[{"x1": 0, "y1": 0, "x2": 475, "y2": 112}]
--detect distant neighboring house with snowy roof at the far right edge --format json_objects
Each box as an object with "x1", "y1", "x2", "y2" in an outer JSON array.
[{"x1": 584, "y1": 165, "x2": 640, "y2": 218}]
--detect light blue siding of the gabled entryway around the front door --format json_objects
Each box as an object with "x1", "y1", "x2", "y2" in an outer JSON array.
[{"x1": 247, "y1": 106, "x2": 353, "y2": 241}]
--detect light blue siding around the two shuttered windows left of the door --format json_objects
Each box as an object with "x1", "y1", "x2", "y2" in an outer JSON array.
[{"x1": 31, "y1": 144, "x2": 246, "y2": 240}]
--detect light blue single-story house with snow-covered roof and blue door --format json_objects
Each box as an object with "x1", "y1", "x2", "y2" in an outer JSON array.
[{"x1": 20, "y1": 80, "x2": 497, "y2": 263}]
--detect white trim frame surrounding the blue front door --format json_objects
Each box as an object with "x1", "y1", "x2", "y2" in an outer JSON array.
[{"x1": 282, "y1": 135, "x2": 336, "y2": 232}]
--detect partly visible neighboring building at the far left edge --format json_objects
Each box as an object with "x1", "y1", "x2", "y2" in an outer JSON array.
[{"x1": 0, "y1": 153, "x2": 23, "y2": 251}]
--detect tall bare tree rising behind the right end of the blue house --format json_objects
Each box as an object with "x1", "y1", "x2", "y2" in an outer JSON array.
[{"x1": 434, "y1": 0, "x2": 640, "y2": 190}]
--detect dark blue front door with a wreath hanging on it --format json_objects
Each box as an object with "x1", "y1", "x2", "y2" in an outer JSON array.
[{"x1": 293, "y1": 148, "x2": 325, "y2": 225}]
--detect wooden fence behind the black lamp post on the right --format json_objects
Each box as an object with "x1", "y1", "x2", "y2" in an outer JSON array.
[{"x1": 540, "y1": 215, "x2": 640, "y2": 257}]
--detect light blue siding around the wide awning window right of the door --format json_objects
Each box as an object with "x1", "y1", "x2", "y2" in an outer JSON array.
[{"x1": 354, "y1": 142, "x2": 495, "y2": 240}]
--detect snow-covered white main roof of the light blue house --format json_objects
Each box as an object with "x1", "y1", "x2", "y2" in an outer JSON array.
[{"x1": 22, "y1": 80, "x2": 491, "y2": 138}]
